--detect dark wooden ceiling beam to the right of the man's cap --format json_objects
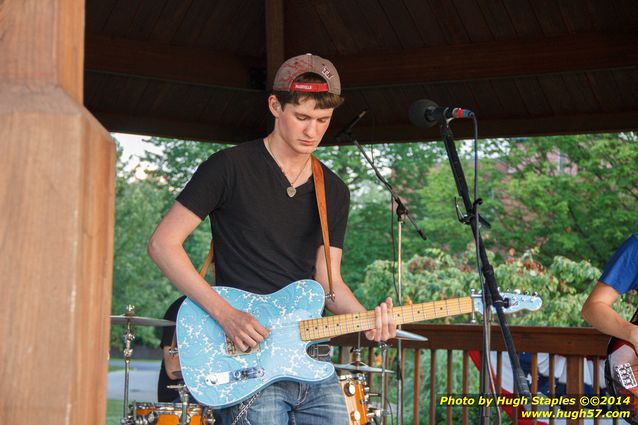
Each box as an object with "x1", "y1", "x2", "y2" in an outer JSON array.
[{"x1": 338, "y1": 33, "x2": 638, "y2": 90}]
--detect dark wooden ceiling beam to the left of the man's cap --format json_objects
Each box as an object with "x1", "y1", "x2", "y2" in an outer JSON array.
[{"x1": 85, "y1": 34, "x2": 264, "y2": 89}]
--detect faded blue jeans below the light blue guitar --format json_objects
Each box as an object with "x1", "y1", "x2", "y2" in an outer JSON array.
[{"x1": 216, "y1": 374, "x2": 348, "y2": 425}]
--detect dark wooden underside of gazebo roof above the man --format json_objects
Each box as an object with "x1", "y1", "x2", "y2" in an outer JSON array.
[{"x1": 85, "y1": 0, "x2": 638, "y2": 144}]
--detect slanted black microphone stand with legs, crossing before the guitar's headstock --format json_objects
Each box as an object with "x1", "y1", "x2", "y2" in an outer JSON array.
[{"x1": 440, "y1": 120, "x2": 531, "y2": 425}]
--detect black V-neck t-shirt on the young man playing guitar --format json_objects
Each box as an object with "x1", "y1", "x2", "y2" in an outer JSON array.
[{"x1": 177, "y1": 139, "x2": 350, "y2": 294}]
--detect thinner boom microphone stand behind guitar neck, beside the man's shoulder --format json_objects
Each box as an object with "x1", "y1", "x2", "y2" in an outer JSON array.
[{"x1": 339, "y1": 130, "x2": 427, "y2": 425}]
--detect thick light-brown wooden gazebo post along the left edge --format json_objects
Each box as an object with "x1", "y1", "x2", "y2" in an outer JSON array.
[{"x1": 0, "y1": 0, "x2": 115, "y2": 425}]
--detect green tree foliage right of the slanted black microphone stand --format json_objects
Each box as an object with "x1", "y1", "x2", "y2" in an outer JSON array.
[{"x1": 484, "y1": 133, "x2": 638, "y2": 267}]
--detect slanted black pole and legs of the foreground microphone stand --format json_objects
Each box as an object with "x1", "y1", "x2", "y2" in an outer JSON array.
[{"x1": 440, "y1": 120, "x2": 531, "y2": 410}]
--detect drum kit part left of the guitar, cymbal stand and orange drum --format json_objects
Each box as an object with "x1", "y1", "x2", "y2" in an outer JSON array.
[{"x1": 111, "y1": 305, "x2": 215, "y2": 425}]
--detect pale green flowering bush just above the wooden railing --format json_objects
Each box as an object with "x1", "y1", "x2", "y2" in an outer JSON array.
[{"x1": 356, "y1": 243, "x2": 634, "y2": 326}]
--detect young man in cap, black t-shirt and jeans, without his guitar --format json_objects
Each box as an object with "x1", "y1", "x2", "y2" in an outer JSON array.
[{"x1": 148, "y1": 54, "x2": 396, "y2": 425}]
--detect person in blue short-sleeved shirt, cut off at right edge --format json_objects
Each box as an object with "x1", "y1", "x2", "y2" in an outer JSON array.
[{"x1": 582, "y1": 233, "x2": 638, "y2": 353}]
